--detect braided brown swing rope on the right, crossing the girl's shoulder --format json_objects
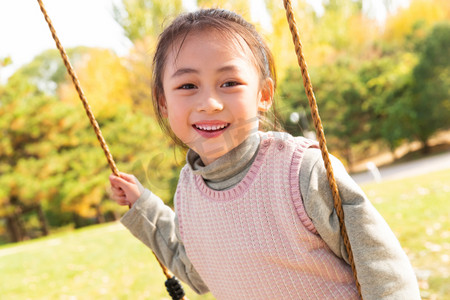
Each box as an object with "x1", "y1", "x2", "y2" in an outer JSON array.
[{"x1": 283, "y1": 0, "x2": 362, "y2": 299}]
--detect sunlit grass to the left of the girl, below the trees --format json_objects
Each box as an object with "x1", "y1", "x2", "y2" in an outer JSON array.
[{"x1": 0, "y1": 223, "x2": 213, "y2": 299}]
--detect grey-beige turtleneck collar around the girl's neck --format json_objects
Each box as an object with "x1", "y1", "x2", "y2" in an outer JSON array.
[{"x1": 186, "y1": 132, "x2": 260, "y2": 191}]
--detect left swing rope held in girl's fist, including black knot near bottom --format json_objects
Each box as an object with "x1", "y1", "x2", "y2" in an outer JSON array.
[{"x1": 37, "y1": 0, "x2": 187, "y2": 300}]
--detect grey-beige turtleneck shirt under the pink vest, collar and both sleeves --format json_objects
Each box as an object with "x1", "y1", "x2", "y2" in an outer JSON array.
[{"x1": 121, "y1": 133, "x2": 420, "y2": 300}]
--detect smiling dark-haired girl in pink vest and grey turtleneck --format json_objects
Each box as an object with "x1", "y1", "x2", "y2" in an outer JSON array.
[{"x1": 110, "y1": 9, "x2": 420, "y2": 300}]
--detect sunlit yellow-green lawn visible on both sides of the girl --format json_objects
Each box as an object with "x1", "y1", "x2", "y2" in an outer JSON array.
[{"x1": 0, "y1": 170, "x2": 450, "y2": 300}]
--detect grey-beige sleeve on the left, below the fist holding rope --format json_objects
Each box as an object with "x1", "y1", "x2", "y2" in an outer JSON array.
[{"x1": 120, "y1": 189, "x2": 209, "y2": 294}]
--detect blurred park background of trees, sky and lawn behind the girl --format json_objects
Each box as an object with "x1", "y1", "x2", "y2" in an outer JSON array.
[{"x1": 0, "y1": 0, "x2": 450, "y2": 299}]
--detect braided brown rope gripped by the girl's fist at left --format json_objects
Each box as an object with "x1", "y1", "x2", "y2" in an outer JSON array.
[{"x1": 37, "y1": 0, "x2": 186, "y2": 300}]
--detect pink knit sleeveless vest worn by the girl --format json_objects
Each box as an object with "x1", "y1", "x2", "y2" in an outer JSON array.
[{"x1": 175, "y1": 133, "x2": 358, "y2": 300}]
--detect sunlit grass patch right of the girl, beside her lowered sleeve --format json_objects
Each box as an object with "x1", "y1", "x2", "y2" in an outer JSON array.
[{"x1": 362, "y1": 170, "x2": 450, "y2": 300}]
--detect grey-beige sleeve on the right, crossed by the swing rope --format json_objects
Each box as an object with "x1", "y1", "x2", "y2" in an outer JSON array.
[{"x1": 299, "y1": 148, "x2": 420, "y2": 300}]
